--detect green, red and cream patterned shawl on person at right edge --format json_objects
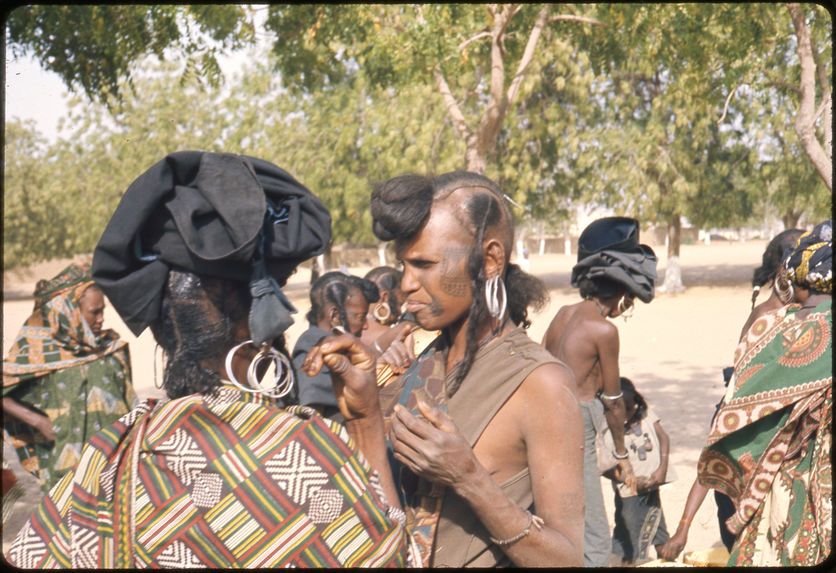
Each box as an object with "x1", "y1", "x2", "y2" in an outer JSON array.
[{"x1": 697, "y1": 300, "x2": 833, "y2": 565}]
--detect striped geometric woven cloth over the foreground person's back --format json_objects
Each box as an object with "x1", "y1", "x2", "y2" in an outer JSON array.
[{"x1": 8, "y1": 385, "x2": 414, "y2": 569}]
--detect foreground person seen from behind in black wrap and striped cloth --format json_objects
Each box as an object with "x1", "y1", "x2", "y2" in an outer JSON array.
[{"x1": 9, "y1": 151, "x2": 408, "y2": 569}]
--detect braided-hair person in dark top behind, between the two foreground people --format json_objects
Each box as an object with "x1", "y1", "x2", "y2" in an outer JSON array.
[{"x1": 293, "y1": 271, "x2": 379, "y2": 421}]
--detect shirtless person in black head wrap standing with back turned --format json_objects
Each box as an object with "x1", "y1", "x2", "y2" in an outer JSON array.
[{"x1": 543, "y1": 217, "x2": 656, "y2": 567}]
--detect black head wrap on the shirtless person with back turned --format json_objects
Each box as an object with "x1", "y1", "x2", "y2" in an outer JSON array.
[{"x1": 571, "y1": 217, "x2": 656, "y2": 303}]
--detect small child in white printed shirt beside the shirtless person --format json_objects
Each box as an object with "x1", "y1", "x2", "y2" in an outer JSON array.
[{"x1": 604, "y1": 377, "x2": 676, "y2": 566}]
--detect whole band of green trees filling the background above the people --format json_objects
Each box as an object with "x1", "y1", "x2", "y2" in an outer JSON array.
[{"x1": 4, "y1": 4, "x2": 832, "y2": 284}]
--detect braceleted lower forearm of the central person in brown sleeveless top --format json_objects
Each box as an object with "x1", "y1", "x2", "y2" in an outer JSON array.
[{"x1": 455, "y1": 462, "x2": 583, "y2": 567}]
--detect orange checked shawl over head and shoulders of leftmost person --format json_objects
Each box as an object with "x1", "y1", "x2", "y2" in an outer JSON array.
[{"x1": 3, "y1": 264, "x2": 127, "y2": 389}]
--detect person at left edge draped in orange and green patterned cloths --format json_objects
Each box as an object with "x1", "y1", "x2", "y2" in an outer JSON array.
[{"x1": 3, "y1": 264, "x2": 136, "y2": 493}]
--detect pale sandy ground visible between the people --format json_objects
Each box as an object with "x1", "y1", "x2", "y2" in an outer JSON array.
[{"x1": 3, "y1": 241, "x2": 766, "y2": 556}]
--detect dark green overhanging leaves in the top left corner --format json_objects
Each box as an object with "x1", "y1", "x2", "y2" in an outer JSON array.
[{"x1": 6, "y1": 4, "x2": 254, "y2": 102}]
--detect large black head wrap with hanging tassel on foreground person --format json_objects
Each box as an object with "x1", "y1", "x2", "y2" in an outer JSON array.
[{"x1": 92, "y1": 151, "x2": 331, "y2": 344}]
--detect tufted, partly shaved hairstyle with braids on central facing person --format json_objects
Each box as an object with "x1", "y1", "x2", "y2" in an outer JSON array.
[{"x1": 371, "y1": 171, "x2": 548, "y2": 395}]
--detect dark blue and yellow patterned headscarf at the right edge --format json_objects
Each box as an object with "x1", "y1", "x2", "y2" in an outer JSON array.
[{"x1": 784, "y1": 219, "x2": 833, "y2": 294}]
